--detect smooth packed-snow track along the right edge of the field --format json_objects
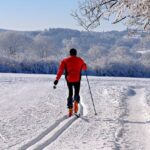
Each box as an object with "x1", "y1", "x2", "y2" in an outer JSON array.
[{"x1": 122, "y1": 87, "x2": 150, "y2": 150}]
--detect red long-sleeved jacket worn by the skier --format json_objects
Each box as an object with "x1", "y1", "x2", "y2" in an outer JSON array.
[{"x1": 56, "y1": 56, "x2": 87, "y2": 82}]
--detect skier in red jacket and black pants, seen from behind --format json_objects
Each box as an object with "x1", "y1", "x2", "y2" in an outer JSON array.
[{"x1": 54, "y1": 48, "x2": 87, "y2": 117}]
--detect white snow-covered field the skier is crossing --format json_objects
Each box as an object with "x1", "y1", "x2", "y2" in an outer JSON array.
[{"x1": 0, "y1": 74, "x2": 150, "y2": 150}]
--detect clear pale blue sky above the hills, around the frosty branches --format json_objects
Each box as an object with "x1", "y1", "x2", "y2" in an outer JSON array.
[{"x1": 0, "y1": 0, "x2": 125, "y2": 31}]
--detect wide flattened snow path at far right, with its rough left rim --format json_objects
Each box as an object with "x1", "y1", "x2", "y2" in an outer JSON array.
[{"x1": 114, "y1": 87, "x2": 150, "y2": 150}]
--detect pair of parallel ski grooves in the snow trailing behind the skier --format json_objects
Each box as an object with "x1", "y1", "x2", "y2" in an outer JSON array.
[{"x1": 20, "y1": 102, "x2": 84, "y2": 150}]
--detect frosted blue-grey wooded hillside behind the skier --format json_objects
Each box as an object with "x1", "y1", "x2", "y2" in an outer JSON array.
[{"x1": 0, "y1": 28, "x2": 150, "y2": 77}]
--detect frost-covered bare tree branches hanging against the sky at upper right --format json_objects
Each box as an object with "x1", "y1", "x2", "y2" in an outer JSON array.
[{"x1": 72, "y1": 0, "x2": 150, "y2": 30}]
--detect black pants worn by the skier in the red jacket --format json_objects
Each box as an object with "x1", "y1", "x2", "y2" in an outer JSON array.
[{"x1": 67, "y1": 82, "x2": 80, "y2": 108}]
